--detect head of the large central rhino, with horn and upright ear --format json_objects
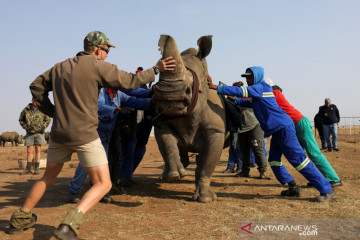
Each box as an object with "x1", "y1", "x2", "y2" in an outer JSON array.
[{"x1": 153, "y1": 35, "x2": 212, "y2": 117}]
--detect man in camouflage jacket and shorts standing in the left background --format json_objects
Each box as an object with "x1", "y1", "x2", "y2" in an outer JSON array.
[{"x1": 19, "y1": 100, "x2": 50, "y2": 175}]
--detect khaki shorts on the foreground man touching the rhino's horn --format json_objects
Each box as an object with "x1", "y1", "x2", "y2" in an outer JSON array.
[{"x1": 47, "y1": 138, "x2": 108, "y2": 167}]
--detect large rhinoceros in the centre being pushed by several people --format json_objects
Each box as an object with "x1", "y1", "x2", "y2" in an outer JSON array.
[{"x1": 152, "y1": 35, "x2": 228, "y2": 202}]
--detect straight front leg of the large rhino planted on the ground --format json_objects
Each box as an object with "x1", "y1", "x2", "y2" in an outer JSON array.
[{"x1": 193, "y1": 133, "x2": 224, "y2": 203}]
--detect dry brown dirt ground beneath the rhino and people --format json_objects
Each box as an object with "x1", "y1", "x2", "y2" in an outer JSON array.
[{"x1": 0, "y1": 137, "x2": 360, "y2": 240}]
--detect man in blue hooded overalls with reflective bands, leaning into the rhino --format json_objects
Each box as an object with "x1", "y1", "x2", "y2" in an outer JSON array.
[{"x1": 208, "y1": 67, "x2": 336, "y2": 202}]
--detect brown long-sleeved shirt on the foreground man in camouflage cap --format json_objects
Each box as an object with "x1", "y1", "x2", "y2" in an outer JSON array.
[{"x1": 30, "y1": 52, "x2": 155, "y2": 145}]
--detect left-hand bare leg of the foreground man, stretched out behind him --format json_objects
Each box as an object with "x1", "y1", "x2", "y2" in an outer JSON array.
[{"x1": 22, "y1": 162, "x2": 64, "y2": 212}]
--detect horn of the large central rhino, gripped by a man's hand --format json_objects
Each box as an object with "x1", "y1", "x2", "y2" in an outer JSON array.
[{"x1": 158, "y1": 35, "x2": 185, "y2": 80}]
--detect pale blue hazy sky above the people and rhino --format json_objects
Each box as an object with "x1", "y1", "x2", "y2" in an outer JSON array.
[{"x1": 0, "y1": 0, "x2": 360, "y2": 134}]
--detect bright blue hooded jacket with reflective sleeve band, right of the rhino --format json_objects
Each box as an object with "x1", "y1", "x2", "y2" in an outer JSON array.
[{"x1": 217, "y1": 67, "x2": 294, "y2": 137}]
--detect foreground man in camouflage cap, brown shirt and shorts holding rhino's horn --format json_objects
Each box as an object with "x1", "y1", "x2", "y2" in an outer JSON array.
[{"x1": 6, "y1": 31, "x2": 176, "y2": 239}]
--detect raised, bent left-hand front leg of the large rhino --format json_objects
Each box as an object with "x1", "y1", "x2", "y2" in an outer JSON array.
[{"x1": 155, "y1": 126, "x2": 186, "y2": 181}]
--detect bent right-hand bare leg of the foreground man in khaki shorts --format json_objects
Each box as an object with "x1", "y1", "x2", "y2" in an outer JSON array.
[{"x1": 76, "y1": 164, "x2": 111, "y2": 214}]
